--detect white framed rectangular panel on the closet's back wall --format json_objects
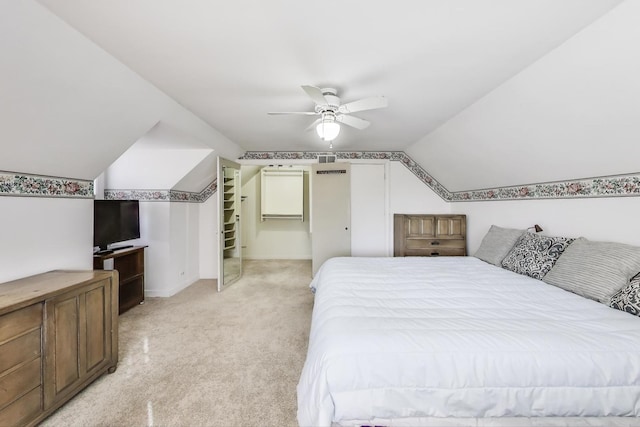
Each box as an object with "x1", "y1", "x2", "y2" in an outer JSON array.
[{"x1": 260, "y1": 168, "x2": 304, "y2": 221}]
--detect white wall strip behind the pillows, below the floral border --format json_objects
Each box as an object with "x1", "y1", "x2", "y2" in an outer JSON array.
[{"x1": 451, "y1": 197, "x2": 640, "y2": 255}]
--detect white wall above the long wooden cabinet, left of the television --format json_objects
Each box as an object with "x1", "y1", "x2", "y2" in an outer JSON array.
[{"x1": 0, "y1": 196, "x2": 93, "y2": 283}]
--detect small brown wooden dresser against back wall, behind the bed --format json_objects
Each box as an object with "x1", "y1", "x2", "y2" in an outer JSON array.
[{"x1": 393, "y1": 214, "x2": 467, "y2": 256}]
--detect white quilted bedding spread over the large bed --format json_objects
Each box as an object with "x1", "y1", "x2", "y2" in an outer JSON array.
[{"x1": 298, "y1": 257, "x2": 640, "y2": 426}]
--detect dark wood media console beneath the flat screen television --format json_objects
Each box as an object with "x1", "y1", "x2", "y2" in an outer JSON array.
[{"x1": 93, "y1": 246, "x2": 146, "y2": 314}]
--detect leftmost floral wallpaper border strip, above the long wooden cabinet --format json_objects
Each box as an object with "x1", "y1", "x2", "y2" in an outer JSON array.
[{"x1": 0, "y1": 171, "x2": 93, "y2": 199}]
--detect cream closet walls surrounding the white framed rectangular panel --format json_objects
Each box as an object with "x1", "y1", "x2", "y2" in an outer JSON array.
[{"x1": 242, "y1": 165, "x2": 311, "y2": 259}]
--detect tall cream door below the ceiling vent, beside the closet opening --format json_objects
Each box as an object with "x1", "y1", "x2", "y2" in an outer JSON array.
[{"x1": 311, "y1": 163, "x2": 351, "y2": 275}]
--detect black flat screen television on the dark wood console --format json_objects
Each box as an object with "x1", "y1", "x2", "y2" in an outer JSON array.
[{"x1": 93, "y1": 200, "x2": 140, "y2": 251}]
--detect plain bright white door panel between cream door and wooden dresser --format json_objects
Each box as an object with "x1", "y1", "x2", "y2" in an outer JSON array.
[{"x1": 351, "y1": 163, "x2": 389, "y2": 256}]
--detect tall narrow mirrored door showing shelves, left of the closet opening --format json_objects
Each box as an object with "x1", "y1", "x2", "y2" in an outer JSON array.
[{"x1": 216, "y1": 157, "x2": 242, "y2": 292}]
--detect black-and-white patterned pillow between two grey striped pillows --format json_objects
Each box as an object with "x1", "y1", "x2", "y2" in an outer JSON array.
[{"x1": 502, "y1": 233, "x2": 573, "y2": 279}]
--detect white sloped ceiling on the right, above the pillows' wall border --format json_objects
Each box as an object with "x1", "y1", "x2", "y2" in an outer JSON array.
[{"x1": 406, "y1": 1, "x2": 640, "y2": 191}]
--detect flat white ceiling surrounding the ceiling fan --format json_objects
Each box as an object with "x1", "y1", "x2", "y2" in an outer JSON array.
[{"x1": 39, "y1": 0, "x2": 620, "y2": 155}]
